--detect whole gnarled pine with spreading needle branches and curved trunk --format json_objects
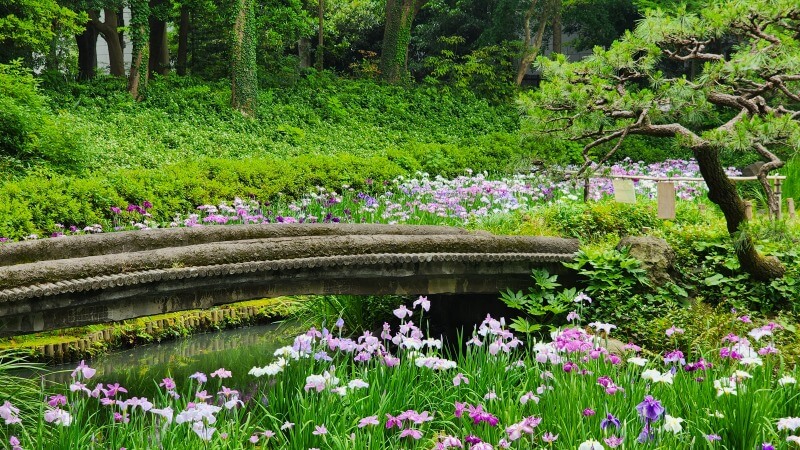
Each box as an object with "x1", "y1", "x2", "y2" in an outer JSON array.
[{"x1": 521, "y1": 0, "x2": 800, "y2": 280}]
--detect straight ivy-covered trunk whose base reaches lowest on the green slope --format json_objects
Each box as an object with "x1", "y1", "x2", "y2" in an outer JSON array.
[{"x1": 231, "y1": 0, "x2": 258, "y2": 116}]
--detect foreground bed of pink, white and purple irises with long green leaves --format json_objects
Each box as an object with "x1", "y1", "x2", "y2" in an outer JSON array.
[{"x1": 0, "y1": 293, "x2": 800, "y2": 450}]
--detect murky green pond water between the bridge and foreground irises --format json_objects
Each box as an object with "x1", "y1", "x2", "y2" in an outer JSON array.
[{"x1": 42, "y1": 322, "x2": 299, "y2": 397}]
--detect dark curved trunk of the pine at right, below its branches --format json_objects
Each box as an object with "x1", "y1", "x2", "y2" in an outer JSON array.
[{"x1": 694, "y1": 146, "x2": 786, "y2": 281}]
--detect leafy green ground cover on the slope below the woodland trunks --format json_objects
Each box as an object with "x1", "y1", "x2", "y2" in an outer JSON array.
[{"x1": 31, "y1": 73, "x2": 523, "y2": 170}]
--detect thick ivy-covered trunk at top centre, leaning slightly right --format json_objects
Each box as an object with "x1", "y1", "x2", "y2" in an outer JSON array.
[{"x1": 379, "y1": 0, "x2": 425, "y2": 83}]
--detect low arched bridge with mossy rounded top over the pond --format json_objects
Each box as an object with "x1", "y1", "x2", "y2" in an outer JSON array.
[{"x1": 0, "y1": 224, "x2": 578, "y2": 336}]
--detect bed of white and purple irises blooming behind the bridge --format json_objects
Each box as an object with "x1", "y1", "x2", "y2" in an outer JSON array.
[{"x1": 0, "y1": 160, "x2": 737, "y2": 242}]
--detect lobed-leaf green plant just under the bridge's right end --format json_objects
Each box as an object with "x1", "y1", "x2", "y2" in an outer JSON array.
[{"x1": 500, "y1": 269, "x2": 577, "y2": 333}]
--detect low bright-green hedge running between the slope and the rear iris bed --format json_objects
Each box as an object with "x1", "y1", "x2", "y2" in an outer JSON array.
[{"x1": 0, "y1": 134, "x2": 532, "y2": 239}]
